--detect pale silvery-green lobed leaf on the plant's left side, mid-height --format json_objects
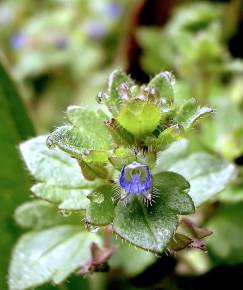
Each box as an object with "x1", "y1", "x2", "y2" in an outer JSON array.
[{"x1": 20, "y1": 136, "x2": 97, "y2": 210}]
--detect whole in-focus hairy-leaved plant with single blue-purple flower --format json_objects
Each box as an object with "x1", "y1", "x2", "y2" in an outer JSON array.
[{"x1": 9, "y1": 70, "x2": 234, "y2": 290}]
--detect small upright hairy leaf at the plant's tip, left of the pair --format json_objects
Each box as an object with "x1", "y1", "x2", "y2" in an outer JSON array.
[{"x1": 105, "y1": 69, "x2": 135, "y2": 117}]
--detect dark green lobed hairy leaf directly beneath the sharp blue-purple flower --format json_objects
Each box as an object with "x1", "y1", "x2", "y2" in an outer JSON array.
[{"x1": 113, "y1": 172, "x2": 194, "y2": 253}]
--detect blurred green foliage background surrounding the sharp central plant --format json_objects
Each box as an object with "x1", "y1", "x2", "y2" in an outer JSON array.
[{"x1": 0, "y1": 0, "x2": 243, "y2": 290}]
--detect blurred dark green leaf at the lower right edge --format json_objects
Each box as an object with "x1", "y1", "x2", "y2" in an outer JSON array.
[{"x1": 206, "y1": 202, "x2": 243, "y2": 264}]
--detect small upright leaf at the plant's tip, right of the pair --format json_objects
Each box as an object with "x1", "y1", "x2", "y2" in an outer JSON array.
[{"x1": 148, "y1": 71, "x2": 175, "y2": 105}]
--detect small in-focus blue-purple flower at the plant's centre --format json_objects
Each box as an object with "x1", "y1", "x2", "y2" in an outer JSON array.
[{"x1": 119, "y1": 162, "x2": 152, "y2": 199}]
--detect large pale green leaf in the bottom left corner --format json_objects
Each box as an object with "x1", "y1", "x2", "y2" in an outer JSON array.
[{"x1": 9, "y1": 225, "x2": 101, "y2": 290}]
